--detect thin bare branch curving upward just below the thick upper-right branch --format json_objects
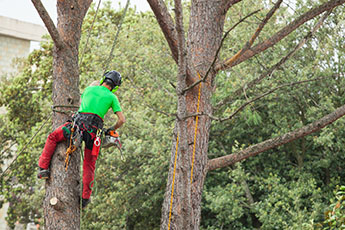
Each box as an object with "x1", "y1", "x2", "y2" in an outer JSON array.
[{"x1": 216, "y1": 10, "x2": 332, "y2": 108}]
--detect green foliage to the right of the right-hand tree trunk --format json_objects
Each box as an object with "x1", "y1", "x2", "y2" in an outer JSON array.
[{"x1": 201, "y1": 2, "x2": 345, "y2": 229}]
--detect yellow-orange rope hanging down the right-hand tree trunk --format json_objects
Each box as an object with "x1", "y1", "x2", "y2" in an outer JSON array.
[{"x1": 168, "y1": 73, "x2": 202, "y2": 230}]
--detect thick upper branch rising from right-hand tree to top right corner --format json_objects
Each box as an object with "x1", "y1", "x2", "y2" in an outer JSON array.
[{"x1": 215, "y1": 0, "x2": 345, "y2": 71}]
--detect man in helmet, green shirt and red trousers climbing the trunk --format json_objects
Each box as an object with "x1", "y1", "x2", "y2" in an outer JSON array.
[{"x1": 37, "y1": 71, "x2": 125, "y2": 208}]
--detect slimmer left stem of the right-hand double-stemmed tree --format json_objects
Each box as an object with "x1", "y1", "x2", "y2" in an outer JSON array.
[{"x1": 161, "y1": 0, "x2": 192, "y2": 229}]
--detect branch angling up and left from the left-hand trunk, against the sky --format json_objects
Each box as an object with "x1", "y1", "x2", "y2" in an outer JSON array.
[{"x1": 31, "y1": 0, "x2": 64, "y2": 49}]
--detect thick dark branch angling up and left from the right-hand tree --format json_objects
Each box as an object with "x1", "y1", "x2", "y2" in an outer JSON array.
[{"x1": 147, "y1": 0, "x2": 178, "y2": 63}]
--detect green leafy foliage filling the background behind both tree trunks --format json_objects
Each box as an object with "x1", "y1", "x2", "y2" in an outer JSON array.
[{"x1": 0, "y1": 1, "x2": 345, "y2": 230}]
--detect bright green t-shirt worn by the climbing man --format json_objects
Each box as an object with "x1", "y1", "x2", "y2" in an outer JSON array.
[{"x1": 78, "y1": 86, "x2": 121, "y2": 119}]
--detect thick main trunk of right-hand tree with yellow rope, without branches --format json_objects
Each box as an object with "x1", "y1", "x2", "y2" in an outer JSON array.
[{"x1": 161, "y1": 1, "x2": 225, "y2": 230}]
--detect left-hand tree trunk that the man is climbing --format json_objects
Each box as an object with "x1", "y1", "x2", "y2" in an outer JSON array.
[{"x1": 32, "y1": 0, "x2": 92, "y2": 230}]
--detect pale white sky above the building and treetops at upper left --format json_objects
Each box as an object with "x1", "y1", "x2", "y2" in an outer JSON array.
[{"x1": 0, "y1": 0, "x2": 150, "y2": 25}]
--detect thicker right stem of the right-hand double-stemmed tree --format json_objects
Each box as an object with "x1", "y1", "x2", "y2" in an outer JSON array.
[{"x1": 187, "y1": 1, "x2": 226, "y2": 229}]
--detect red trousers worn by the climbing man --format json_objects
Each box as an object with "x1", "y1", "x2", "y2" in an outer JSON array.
[{"x1": 38, "y1": 123, "x2": 97, "y2": 199}]
